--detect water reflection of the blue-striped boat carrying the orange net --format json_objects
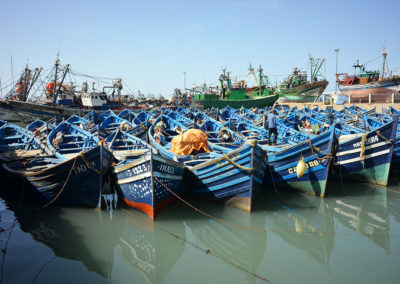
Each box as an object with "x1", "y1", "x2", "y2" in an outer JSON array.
[{"x1": 185, "y1": 202, "x2": 267, "y2": 283}]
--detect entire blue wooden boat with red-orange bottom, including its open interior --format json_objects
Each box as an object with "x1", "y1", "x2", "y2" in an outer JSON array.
[{"x1": 106, "y1": 131, "x2": 184, "y2": 219}]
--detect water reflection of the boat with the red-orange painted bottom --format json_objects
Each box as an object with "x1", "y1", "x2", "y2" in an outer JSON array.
[{"x1": 114, "y1": 209, "x2": 186, "y2": 283}]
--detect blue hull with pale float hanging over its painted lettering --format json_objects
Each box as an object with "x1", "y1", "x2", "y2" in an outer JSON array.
[{"x1": 265, "y1": 130, "x2": 336, "y2": 197}]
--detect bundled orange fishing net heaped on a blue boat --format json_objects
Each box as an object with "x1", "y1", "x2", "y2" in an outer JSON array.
[{"x1": 171, "y1": 129, "x2": 210, "y2": 156}]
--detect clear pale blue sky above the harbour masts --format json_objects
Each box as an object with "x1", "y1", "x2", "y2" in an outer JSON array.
[{"x1": 0, "y1": 0, "x2": 400, "y2": 96}]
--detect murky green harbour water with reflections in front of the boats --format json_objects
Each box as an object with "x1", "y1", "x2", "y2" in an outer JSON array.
[{"x1": 0, "y1": 180, "x2": 400, "y2": 283}]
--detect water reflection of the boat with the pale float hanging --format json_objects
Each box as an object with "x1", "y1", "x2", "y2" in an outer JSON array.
[{"x1": 266, "y1": 192, "x2": 335, "y2": 266}]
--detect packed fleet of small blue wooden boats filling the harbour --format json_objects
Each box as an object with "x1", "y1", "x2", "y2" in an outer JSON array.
[{"x1": 0, "y1": 105, "x2": 400, "y2": 219}]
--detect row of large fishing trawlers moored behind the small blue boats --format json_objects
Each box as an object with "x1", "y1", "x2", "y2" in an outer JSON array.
[{"x1": 0, "y1": 48, "x2": 400, "y2": 123}]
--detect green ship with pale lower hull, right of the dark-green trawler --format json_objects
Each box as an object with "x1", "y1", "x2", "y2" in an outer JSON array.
[{"x1": 277, "y1": 56, "x2": 329, "y2": 102}]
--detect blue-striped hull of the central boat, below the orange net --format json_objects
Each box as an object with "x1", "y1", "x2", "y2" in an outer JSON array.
[{"x1": 185, "y1": 144, "x2": 267, "y2": 212}]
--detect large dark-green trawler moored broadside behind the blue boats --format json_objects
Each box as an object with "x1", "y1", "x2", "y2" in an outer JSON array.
[{"x1": 191, "y1": 66, "x2": 278, "y2": 109}]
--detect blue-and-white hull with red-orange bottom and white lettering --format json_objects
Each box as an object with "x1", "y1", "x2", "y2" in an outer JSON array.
[{"x1": 114, "y1": 153, "x2": 184, "y2": 219}]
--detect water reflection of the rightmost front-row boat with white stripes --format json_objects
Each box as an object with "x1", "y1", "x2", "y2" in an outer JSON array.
[{"x1": 326, "y1": 183, "x2": 390, "y2": 255}]
